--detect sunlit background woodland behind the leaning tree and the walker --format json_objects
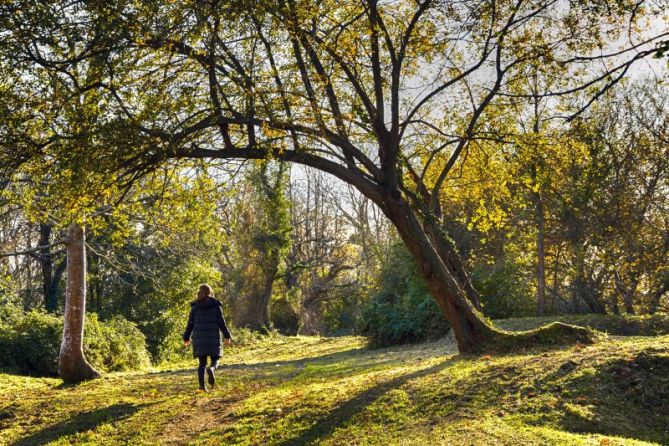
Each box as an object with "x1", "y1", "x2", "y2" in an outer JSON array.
[{"x1": 0, "y1": 81, "x2": 669, "y2": 366}]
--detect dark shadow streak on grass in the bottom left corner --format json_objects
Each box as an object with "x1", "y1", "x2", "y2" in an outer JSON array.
[{"x1": 11, "y1": 403, "x2": 143, "y2": 446}]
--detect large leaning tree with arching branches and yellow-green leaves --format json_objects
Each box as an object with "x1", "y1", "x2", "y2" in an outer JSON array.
[{"x1": 2, "y1": 0, "x2": 669, "y2": 351}]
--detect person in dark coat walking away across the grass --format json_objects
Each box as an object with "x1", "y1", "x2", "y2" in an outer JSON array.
[{"x1": 183, "y1": 284, "x2": 232, "y2": 392}]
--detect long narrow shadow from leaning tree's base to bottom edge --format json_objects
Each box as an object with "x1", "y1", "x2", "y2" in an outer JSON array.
[{"x1": 276, "y1": 360, "x2": 451, "y2": 446}]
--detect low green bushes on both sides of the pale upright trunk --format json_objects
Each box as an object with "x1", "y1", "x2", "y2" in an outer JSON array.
[{"x1": 0, "y1": 308, "x2": 149, "y2": 376}]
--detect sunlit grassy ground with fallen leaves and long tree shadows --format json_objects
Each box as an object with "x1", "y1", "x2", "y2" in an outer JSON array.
[{"x1": 0, "y1": 318, "x2": 669, "y2": 446}]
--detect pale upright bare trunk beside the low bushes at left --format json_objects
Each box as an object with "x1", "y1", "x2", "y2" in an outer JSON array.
[{"x1": 58, "y1": 224, "x2": 100, "y2": 383}]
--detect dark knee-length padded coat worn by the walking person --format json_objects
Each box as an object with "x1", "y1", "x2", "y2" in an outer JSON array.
[{"x1": 183, "y1": 297, "x2": 232, "y2": 357}]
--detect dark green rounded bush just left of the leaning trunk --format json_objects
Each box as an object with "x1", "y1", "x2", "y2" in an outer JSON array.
[{"x1": 360, "y1": 244, "x2": 449, "y2": 346}]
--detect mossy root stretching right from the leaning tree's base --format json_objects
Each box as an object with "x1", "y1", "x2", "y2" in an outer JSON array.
[{"x1": 468, "y1": 322, "x2": 606, "y2": 353}]
